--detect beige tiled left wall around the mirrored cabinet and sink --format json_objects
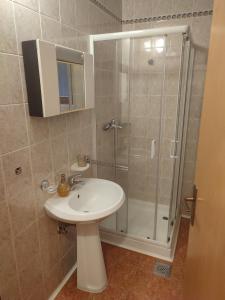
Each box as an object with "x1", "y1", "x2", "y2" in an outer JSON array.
[{"x1": 0, "y1": 0, "x2": 121, "y2": 300}]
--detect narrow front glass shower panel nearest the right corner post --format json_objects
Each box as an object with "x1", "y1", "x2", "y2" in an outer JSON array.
[{"x1": 155, "y1": 34, "x2": 184, "y2": 243}]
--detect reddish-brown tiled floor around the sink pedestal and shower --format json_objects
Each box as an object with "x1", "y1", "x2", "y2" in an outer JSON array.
[{"x1": 56, "y1": 219, "x2": 189, "y2": 300}]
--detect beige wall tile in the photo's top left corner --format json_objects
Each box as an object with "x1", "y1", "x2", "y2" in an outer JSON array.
[{"x1": 0, "y1": 0, "x2": 17, "y2": 53}]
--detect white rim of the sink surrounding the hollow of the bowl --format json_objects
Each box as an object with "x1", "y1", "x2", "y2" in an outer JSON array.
[{"x1": 44, "y1": 178, "x2": 125, "y2": 224}]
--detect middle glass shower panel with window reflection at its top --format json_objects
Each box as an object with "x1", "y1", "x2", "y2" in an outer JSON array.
[{"x1": 128, "y1": 36, "x2": 167, "y2": 239}]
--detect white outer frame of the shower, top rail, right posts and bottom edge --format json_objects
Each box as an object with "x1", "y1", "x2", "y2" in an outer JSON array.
[{"x1": 89, "y1": 25, "x2": 195, "y2": 261}]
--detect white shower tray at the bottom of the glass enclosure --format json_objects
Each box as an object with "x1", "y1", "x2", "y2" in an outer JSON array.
[{"x1": 101, "y1": 199, "x2": 180, "y2": 261}]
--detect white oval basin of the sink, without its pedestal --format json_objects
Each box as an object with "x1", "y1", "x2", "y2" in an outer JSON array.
[{"x1": 45, "y1": 178, "x2": 125, "y2": 224}]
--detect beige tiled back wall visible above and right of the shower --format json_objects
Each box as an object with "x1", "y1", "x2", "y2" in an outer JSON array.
[{"x1": 122, "y1": 0, "x2": 213, "y2": 213}]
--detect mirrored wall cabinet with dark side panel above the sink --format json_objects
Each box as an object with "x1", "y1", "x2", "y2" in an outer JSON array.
[{"x1": 22, "y1": 40, "x2": 94, "y2": 117}]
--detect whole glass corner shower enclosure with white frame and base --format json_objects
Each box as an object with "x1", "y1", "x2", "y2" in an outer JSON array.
[{"x1": 90, "y1": 26, "x2": 194, "y2": 259}]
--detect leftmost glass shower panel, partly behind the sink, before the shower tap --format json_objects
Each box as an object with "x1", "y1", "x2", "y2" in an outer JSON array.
[{"x1": 94, "y1": 40, "x2": 129, "y2": 232}]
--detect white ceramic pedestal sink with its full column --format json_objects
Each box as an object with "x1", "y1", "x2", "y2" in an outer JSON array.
[{"x1": 45, "y1": 178, "x2": 125, "y2": 293}]
